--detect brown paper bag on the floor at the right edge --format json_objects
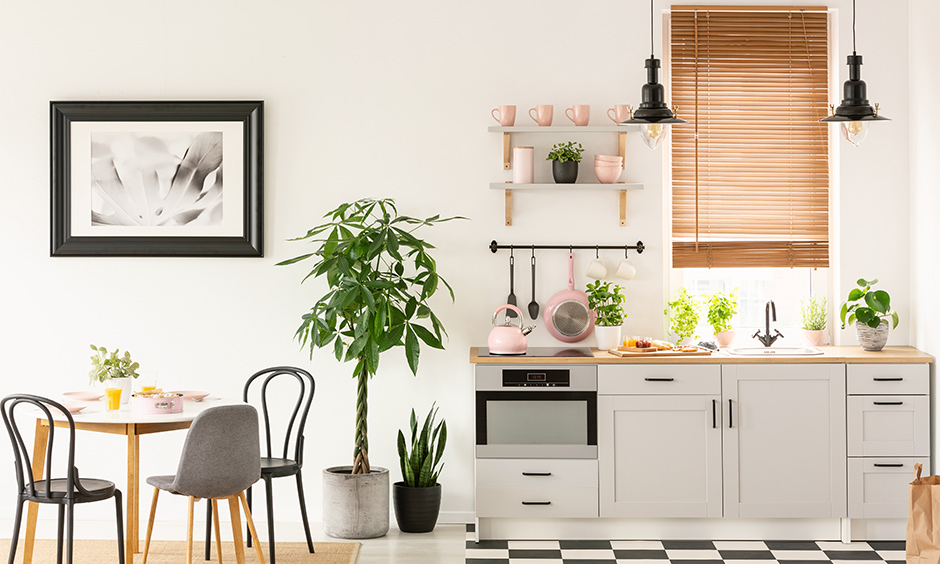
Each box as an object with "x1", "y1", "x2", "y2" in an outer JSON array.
[{"x1": 905, "y1": 462, "x2": 940, "y2": 564}]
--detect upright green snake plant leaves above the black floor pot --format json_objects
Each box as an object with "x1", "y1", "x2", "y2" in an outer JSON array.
[{"x1": 398, "y1": 404, "x2": 447, "y2": 488}]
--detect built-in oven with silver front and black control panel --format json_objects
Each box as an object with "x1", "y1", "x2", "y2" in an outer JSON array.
[{"x1": 476, "y1": 365, "x2": 597, "y2": 459}]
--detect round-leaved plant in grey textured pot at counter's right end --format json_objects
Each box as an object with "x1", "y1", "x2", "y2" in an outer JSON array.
[{"x1": 839, "y1": 278, "x2": 898, "y2": 351}]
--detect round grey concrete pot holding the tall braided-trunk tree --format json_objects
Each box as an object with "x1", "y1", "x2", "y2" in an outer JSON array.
[{"x1": 323, "y1": 466, "x2": 389, "y2": 539}]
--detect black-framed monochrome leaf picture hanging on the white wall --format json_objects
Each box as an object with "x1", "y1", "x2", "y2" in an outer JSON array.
[{"x1": 50, "y1": 101, "x2": 264, "y2": 257}]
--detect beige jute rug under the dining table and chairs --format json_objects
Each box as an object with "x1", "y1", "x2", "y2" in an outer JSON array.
[{"x1": 0, "y1": 539, "x2": 359, "y2": 564}]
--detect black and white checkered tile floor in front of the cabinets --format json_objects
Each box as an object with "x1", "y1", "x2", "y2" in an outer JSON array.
[{"x1": 466, "y1": 525, "x2": 904, "y2": 564}]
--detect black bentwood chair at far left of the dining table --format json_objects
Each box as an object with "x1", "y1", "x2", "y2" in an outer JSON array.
[{"x1": 0, "y1": 394, "x2": 124, "y2": 564}]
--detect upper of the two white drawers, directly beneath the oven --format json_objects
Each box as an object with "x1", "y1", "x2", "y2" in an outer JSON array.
[{"x1": 476, "y1": 458, "x2": 597, "y2": 488}]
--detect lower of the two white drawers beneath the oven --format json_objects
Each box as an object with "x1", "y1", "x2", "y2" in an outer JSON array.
[{"x1": 476, "y1": 487, "x2": 597, "y2": 518}]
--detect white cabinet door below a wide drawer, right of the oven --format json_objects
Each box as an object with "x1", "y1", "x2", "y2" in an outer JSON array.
[{"x1": 597, "y1": 395, "x2": 721, "y2": 517}]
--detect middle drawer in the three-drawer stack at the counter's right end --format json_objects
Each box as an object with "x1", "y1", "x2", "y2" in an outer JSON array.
[{"x1": 847, "y1": 396, "x2": 930, "y2": 456}]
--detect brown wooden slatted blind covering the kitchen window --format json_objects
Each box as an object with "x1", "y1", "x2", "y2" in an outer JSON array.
[{"x1": 670, "y1": 6, "x2": 829, "y2": 268}]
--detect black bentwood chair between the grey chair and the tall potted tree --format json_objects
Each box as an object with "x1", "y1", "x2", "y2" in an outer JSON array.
[{"x1": 206, "y1": 366, "x2": 316, "y2": 564}]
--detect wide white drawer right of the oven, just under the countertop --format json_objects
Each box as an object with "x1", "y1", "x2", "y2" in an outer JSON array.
[{"x1": 597, "y1": 364, "x2": 721, "y2": 395}]
